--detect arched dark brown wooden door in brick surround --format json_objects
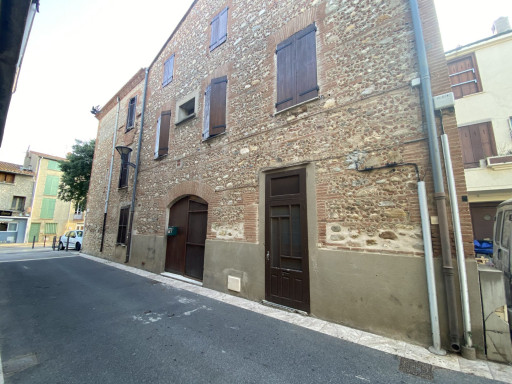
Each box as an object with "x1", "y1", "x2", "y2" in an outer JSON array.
[{"x1": 165, "y1": 196, "x2": 208, "y2": 280}]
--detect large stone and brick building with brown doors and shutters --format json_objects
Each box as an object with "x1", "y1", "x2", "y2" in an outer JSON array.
[{"x1": 84, "y1": 0, "x2": 483, "y2": 353}]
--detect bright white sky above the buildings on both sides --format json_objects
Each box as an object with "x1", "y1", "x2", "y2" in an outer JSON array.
[{"x1": 0, "y1": 0, "x2": 512, "y2": 164}]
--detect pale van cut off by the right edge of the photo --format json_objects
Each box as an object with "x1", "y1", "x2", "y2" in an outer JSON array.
[{"x1": 492, "y1": 199, "x2": 512, "y2": 312}]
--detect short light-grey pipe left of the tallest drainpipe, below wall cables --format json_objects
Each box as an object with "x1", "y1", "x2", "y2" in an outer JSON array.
[{"x1": 418, "y1": 181, "x2": 446, "y2": 356}]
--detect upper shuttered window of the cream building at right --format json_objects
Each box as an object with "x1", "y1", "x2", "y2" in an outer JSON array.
[{"x1": 448, "y1": 54, "x2": 482, "y2": 99}]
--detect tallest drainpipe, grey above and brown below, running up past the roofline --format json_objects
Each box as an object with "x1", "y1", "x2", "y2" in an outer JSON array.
[{"x1": 409, "y1": 0, "x2": 460, "y2": 352}]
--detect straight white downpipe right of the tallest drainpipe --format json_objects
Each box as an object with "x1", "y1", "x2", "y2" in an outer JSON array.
[{"x1": 441, "y1": 134, "x2": 473, "y2": 348}]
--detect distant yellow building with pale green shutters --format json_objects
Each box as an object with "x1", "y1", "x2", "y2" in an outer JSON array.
[{"x1": 23, "y1": 150, "x2": 76, "y2": 242}]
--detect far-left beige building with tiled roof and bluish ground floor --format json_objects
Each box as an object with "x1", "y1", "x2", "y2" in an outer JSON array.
[{"x1": 0, "y1": 161, "x2": 34, "y2": 243}]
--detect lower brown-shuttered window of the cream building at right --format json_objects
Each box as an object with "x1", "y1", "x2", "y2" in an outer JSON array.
[{"x1": 459, "y1": 122, "x2": 496, "y2": 168}]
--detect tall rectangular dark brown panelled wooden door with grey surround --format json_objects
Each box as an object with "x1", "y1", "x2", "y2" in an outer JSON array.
[{"x1": 265, "y1": 169, "x2": 309, "y2": 312}]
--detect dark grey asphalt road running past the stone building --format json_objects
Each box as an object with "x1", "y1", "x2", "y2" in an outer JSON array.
[{"x1": 0, "y1": 252, "x2": 492, "y2": 384}]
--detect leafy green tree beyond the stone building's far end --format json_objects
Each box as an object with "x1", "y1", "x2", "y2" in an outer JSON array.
[{"x1": 59, "y1": 140, "x2": 95, "y2": 210}]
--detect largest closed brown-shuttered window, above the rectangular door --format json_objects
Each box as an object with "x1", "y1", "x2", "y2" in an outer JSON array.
[{"x1": 276, "y1": 24, "x2": 319, "y2": 111}]
